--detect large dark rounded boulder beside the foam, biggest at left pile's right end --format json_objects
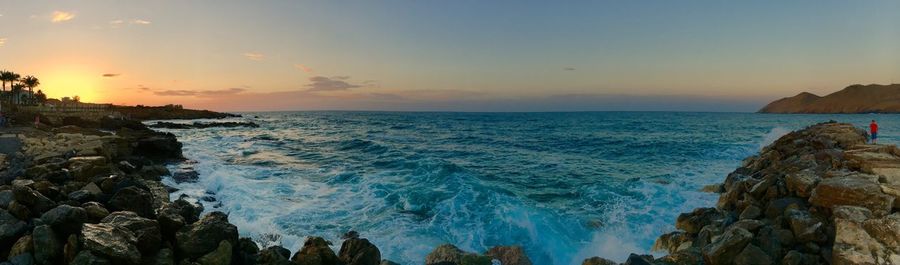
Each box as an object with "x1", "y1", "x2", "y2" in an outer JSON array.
[{"x1": 175, "y1": 212, "x2": 238, "y2": 259}]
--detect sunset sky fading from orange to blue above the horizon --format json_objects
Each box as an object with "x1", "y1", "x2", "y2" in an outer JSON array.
[{"x1": 0, "y1": 0, "x2": 900, "y2": 111}]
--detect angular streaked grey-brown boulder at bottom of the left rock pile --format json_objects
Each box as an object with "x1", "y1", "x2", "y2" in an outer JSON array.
[{"x1": 75, "y1": 224, "x2": 141, "y2": 264}]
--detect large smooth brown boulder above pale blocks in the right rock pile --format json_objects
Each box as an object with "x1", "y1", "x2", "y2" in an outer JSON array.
[{"x1": 809, "y1": 175, "x2": 894, "y2": 216}]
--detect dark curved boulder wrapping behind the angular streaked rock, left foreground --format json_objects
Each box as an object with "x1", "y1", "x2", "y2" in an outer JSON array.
[{"x1": 101, "y1": 211, "x2": 162, "y2": 254}]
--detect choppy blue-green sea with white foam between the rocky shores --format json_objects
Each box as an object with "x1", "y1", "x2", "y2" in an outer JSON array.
[{"x1": 151, "y1": 111, "x2": 900, "y2": 265}]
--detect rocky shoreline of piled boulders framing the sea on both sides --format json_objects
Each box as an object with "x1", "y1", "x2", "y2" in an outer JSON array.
[{"x1": 0, "y1": 120, "x2": 900, "y2": 265}]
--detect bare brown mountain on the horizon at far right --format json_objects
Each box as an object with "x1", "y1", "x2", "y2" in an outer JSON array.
[{"x1": 759, "y1": 84, "x2": 900, "y2": 113}]
